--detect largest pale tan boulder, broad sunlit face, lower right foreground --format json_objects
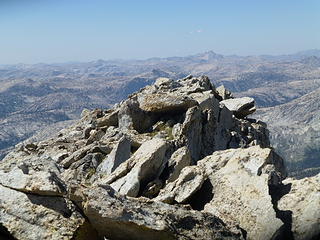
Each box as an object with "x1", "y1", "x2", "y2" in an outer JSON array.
[{"x1": 198, "y1": 146, "x2": 283, "y2": 239}]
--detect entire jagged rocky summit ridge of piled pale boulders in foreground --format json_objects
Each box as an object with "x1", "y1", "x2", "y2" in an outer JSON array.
[{"x1": 0, "y1": 76, "x2": 320, "y2": 240}]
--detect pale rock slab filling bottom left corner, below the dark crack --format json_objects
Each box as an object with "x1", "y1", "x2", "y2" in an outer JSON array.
[{"x1": 0, "y1": 185, "x2": 85, "y2": 240}]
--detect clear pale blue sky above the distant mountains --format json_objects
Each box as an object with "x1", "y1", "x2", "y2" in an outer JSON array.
[{"x1": 0, "y1": 0, "x2": 320, "y2": 64}]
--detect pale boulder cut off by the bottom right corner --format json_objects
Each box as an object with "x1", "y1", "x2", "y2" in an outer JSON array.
[{"x1": 278, "y1": 174, "x2": 320, "y2": 240}]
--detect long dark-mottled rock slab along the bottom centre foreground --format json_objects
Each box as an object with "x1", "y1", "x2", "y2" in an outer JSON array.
[{"x1": 82, "y1": 185, "x2": 243, "y2": 240}]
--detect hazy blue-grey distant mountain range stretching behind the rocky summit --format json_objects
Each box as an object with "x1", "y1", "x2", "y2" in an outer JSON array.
[{"x1": 0, "y1": 49, "x2": 320, "y2": 177}]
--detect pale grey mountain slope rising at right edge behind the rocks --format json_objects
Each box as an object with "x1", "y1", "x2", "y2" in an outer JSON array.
[{"x1": 255, "y1": 88, "x2": 320, "y2": 177}]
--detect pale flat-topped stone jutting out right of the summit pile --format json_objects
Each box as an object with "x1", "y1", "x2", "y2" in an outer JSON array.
[{"x1": 220, "y1": 97, "x2": 256, "y2": 118}]
